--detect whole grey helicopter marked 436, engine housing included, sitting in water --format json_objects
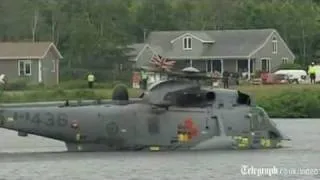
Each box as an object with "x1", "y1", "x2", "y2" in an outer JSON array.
[{"x1": 0, "y1": 80, "x2": 289, "y2": 151}]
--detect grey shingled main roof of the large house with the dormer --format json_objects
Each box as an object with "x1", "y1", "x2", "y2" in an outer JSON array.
[{"x1": 138, "y1": 29, "x2": 292, "y2": 59}]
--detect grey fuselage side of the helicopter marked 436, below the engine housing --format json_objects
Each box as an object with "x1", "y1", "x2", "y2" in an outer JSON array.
[{"x1": 1, "y1": 100, "x2": 288, "y2": 151}]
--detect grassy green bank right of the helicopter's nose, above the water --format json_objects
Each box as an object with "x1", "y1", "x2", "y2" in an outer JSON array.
[{"x1": 240, "y1": 85, "x2": 320, "y2": 118}]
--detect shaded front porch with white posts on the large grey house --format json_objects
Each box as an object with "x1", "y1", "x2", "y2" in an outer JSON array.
[{"x1": 175, "y1": 59, "x2": 260, "y2": 79}]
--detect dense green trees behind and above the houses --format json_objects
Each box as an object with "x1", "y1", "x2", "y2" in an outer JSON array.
[{"x1": 0, "y1": 0, "x2": 320, "y2": 79}]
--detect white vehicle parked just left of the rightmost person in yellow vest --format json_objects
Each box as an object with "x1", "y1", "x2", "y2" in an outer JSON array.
[{"x1": 274, "y1": 69, "x2": 308, "y2": 84}]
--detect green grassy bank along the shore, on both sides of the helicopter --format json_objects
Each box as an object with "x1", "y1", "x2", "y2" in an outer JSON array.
[{"x1": 1, "y1": 84, "x2": 320, "y2": 118}]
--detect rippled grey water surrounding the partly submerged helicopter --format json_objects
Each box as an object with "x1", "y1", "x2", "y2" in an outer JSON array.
[{"x1": 0, "y1": 119, "x2": 320, "y2": 180}]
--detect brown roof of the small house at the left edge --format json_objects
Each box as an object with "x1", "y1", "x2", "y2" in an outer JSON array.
[{"x1": 0, "y1": 42, "x2": 63, "y2": 60}]
